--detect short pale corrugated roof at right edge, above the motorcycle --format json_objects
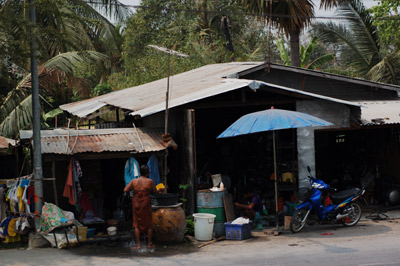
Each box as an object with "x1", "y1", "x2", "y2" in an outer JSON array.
[{"x1": 357, "y1": 101, "x2": 400, "y2": 125}]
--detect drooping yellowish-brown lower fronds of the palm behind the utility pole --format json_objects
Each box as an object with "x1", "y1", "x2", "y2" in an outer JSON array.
[{"x1": 0, "y1": 51, "x2": 107, "y2": 137}]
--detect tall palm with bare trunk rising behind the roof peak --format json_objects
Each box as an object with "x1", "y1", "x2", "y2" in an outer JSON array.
[{"x1": 242, "y1": 0, "x2": 314, "y2": 67}]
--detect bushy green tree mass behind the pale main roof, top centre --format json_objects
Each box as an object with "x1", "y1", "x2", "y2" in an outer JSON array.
[{"x1": 112, "y1": 0, "x2": 276, "y2": 89}]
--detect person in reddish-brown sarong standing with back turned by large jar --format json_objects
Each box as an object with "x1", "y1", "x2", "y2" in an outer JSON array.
[{"x1": 124, "y1": 165, "x2": 161, "y2": 250}]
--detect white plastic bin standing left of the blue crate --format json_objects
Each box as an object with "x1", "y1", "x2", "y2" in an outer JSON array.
[{"x1": 193, "y1": 213, "x2": 215, "y2": 241}]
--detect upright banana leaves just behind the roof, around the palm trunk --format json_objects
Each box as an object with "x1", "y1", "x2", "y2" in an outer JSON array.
[{"x1": 276, "y1": 37, "x2": 335, "y2": 69}]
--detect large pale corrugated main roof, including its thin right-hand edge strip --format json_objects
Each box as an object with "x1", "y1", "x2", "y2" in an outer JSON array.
[{"x1": 60, "y1": 62, "x2": 359, "y2": 117}]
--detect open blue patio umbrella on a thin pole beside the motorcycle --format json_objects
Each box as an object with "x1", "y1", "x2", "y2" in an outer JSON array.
[{"x1": 217, "y1": 107, "x2": 333, "y2": 229}]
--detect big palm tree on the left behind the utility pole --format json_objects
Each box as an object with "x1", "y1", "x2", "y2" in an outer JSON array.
[{"x1": 0, "y1": 0, "x2": 130, "y2": 136}]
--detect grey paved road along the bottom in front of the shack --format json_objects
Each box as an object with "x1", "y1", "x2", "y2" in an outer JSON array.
[{"x1": 0, "y1": 220, "x2": 400, "y2": 266}]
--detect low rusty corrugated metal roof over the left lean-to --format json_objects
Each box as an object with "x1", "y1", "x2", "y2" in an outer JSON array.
[{"x1": 20, "y1": 128, "x2": 172, "y2": 155}]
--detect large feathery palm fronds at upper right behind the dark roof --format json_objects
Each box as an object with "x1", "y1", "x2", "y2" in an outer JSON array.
[{"x1": 313, "y1": 0, "x2": 400, "y2": 84}]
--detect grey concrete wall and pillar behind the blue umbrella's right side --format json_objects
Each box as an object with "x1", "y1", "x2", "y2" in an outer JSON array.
[{"x1": 296, "y1": 100, "x2": 350, "y2": 188}]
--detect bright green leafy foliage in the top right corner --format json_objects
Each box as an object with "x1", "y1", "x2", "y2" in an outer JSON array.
[{"x1": 370, "y1": 0, "x2": 400, "y2": 51}]
